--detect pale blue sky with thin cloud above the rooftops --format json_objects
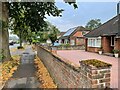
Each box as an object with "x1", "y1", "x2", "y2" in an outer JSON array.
[{"x1": 47, "y1": 0, "x2": 118, "y2": 31}]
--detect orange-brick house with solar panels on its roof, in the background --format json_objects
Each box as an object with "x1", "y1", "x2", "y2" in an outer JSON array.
[{"x1": 59, "y1": 26, "x2": 89, "y2": 45}]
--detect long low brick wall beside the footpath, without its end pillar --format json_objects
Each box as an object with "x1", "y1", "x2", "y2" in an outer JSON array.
[{"x1": 37, "y1": 47, "x2": 91, "y2": 88}]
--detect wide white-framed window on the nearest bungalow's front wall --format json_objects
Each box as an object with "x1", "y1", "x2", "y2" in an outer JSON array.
[{"x1": 88, "y1": 38, "x2": 101, "y2": 47}]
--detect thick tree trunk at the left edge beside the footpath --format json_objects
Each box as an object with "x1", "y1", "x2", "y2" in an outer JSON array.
[{"x1": 0, "y1": 2, "x2": 11, "y2": 61}]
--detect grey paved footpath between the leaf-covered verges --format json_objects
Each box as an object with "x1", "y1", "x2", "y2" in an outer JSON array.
[{"x1": 3, "y1": 46, "x2": 40, "y2": 90}]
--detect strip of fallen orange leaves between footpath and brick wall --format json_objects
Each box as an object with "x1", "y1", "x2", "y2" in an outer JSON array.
[{"x1": 34, "y1": 57, "x2": 57, "y2": 88}]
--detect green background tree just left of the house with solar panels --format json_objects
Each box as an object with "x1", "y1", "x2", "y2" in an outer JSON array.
[{"x1": 33, "y1": 21, "x2": 60, "y2": 43}]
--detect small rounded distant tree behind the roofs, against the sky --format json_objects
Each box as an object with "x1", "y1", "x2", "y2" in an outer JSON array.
[{"x1": 85, "y1": 19, "x2": 101, "y2": 30}]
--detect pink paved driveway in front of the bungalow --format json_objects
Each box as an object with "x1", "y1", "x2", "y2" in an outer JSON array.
[{"x1": 57, "y1": 50, "x2": 120, "y2": 88}]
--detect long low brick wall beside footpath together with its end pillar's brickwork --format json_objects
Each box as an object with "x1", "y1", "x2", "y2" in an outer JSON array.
[{"x1": 37, "y1": 46, "x2": 110, "y2": 88}]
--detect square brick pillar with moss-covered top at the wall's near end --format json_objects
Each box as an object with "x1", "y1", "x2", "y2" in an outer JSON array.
[{"x1": 80, "y1": 60, "x2": 111, "y2": 88}]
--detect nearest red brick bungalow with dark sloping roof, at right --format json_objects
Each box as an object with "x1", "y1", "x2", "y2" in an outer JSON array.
[{"x1": 85, "y1": 16, "x2": 120, "y2": 53}]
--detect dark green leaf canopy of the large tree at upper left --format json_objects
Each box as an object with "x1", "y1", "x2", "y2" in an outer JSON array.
[{"x1": 9, "y1": 2, "x2": 63, "y2": 32}]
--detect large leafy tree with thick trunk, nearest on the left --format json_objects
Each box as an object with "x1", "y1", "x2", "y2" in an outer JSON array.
[{"x1": 0, "y1": 2, "x2": 77, "y2": 60}]
